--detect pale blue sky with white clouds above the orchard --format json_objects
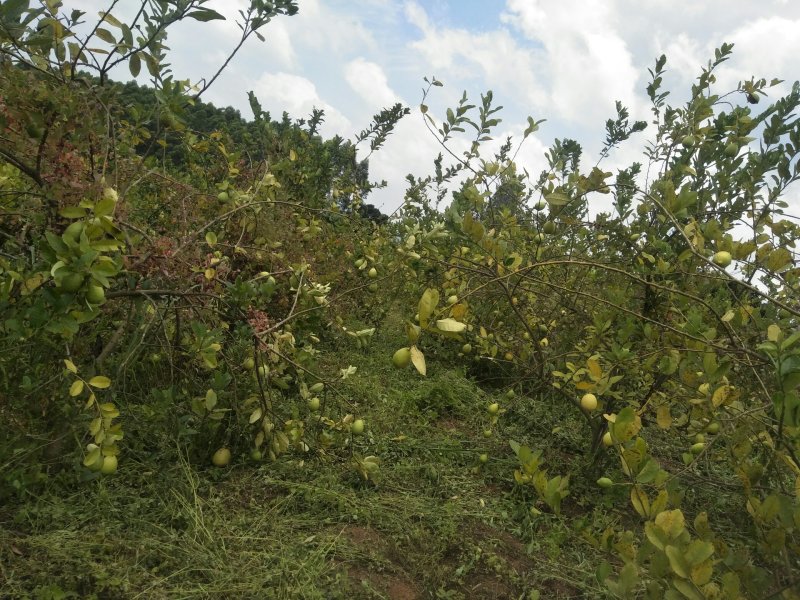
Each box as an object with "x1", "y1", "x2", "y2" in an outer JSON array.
[{"x1": 70, "y1": 0, "x2": 800, "y2": 213}]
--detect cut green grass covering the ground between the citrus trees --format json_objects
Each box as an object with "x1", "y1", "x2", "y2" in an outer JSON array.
[{"x1": 0, "y1": 312, "x2": 692, "y2": 600}]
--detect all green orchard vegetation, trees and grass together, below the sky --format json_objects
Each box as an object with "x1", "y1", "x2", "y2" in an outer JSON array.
[{"x1": 0, "y1": 0, "x2": 800, "y2": 600}]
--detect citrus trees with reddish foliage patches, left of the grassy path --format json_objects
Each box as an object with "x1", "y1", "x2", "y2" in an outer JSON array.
[{"x1": 0, "y1": 0, "x2": 407, "y2": 495}]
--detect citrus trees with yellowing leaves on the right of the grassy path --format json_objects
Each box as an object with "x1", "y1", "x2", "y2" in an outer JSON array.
[{"x1": 396, "y1": 45, "x2": 800, "y2": 599}]
